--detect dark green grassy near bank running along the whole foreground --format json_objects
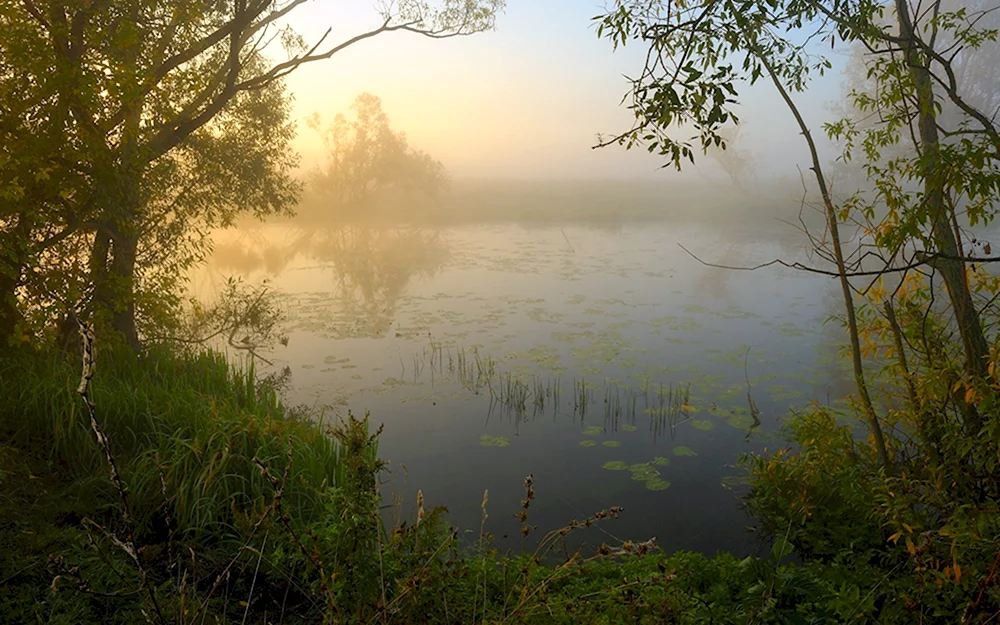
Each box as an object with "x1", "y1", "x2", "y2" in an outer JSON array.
[{"x1": 0, "y1": 350, "x2": 997, "y2": 623}]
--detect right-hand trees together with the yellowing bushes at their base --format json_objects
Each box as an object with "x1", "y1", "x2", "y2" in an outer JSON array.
[{"x1": 596, "y1": 0, "x2": 1000, "y2": 622}]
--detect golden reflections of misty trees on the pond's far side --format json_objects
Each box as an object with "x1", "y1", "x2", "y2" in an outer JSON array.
[{"x1": 213, "y1": 226, "x2": 448, "y2": 336}]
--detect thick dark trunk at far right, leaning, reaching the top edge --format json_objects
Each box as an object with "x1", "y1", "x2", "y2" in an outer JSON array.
[{"x1": 896, "y1": 0, "x2": 989, "y2": 434}]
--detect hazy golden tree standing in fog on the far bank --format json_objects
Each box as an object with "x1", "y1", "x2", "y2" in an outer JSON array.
[{"x1": 308, "y1": 93, "x2": 448, "y2": 206}]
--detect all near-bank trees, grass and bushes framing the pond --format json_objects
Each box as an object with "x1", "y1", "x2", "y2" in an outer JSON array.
[{"x1": 0, "y1": 0, "x2": 1000, "y2": 625}]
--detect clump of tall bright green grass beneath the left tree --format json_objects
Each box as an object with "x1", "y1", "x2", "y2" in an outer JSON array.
[{"x1": 0, "y1": 349, "x2": 343, "y2": 538}]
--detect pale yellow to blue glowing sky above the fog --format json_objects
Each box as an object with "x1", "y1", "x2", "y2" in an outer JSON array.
[{"x1": 278, "y1": 0, "x2": 848, "y2": 179}]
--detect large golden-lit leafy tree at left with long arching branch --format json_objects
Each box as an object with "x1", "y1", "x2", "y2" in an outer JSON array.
[{"x1": 0, "y1": 0, "x2": 503, "y2": 346}]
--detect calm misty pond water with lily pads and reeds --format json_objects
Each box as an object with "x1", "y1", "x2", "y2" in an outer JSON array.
[{"x1": 193, "y1": 219, "x2": 845, "y2": 554}]
